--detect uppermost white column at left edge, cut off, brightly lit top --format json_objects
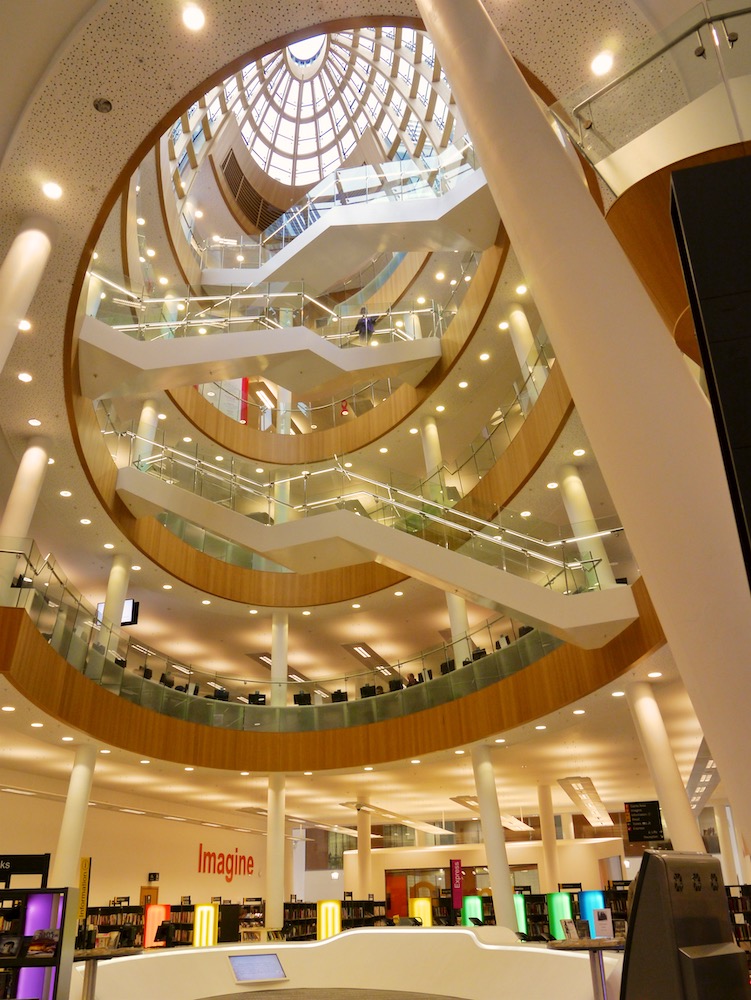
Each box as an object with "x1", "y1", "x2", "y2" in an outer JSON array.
[{"x1": 0, "y1": 219, "x2": 55, "y2": 371}]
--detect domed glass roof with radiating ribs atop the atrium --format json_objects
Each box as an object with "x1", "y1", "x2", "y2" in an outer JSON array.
[{"x1": 225, "y1": 27, "x2": 456, "y2": 187}]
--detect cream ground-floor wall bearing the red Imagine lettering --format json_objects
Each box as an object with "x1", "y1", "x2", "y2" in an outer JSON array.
[{"x1": 0, "y1": 792, "x2": 266, "y2": 906}]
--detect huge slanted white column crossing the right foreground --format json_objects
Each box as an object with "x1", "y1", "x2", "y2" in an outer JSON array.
[{"x1": 416, "y1": 0, "x2": 751, "y2": 840}]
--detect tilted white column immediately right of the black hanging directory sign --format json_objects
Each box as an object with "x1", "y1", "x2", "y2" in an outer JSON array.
[{"x1": 626, "y1": 681, "x2": 704, "y2": 854}]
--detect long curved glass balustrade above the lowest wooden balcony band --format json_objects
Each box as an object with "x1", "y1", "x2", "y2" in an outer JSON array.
[{"x1": 0, "y1": 538, "x2": 562, "y2": 732}]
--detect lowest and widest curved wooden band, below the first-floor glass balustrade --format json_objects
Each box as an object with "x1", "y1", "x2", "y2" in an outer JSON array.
[{"x1": 0, "y1": 580, "x2": 665, "y2": 772}]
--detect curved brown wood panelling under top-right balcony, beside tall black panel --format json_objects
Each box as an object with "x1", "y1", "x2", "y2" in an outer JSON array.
[{"x1": 607, "y1": 137, "x2": 751, "y2": 365}]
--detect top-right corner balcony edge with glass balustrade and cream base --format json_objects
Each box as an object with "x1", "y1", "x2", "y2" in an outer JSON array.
[{"x1": 551, "y1": 2, "x2": 751, "y2": 194}]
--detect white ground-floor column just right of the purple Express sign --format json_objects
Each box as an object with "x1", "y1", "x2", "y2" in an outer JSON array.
[{"x1": 472, "y1": 743, "x2": 519, "y2": 931}]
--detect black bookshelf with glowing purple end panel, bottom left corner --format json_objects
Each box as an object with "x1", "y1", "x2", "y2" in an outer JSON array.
[{"x1": 0, "y1": 889, "x2": 67, "y2": 1000}]
